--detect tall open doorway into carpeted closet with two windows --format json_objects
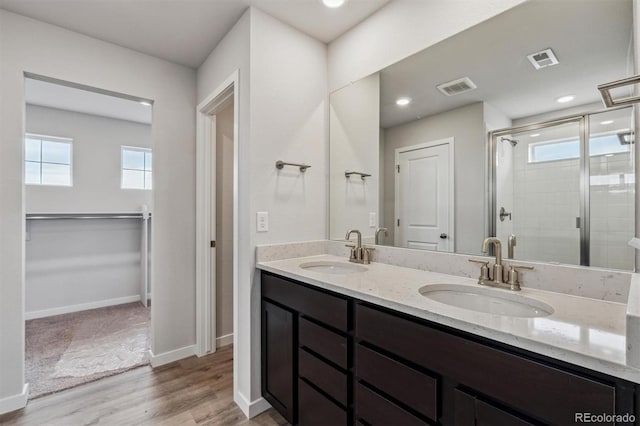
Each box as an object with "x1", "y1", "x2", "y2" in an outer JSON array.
[{"x1": 24, "y1": 75, "x2": 153, "y2": 398}]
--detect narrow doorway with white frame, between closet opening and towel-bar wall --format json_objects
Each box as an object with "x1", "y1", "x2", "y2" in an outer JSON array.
[{"x1": 196, "y1": 71, "x2": 239, "y2": 360}]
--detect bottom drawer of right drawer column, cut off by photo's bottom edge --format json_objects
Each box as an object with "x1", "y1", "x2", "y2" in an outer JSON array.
[{"x1": 356, "y1": 383, "x2": 427, "y2": 426}]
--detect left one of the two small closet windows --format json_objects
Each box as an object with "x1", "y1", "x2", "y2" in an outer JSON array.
[{"x1": 24, "y1": 134, "x2": 72, "y2": 186}]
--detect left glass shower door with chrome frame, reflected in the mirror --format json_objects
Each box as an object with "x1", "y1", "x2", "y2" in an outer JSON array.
[{"x1": 494, "y1": 118, "x2": 583, "y2": 265}]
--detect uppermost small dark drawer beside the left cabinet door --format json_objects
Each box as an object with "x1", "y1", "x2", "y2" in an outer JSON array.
[{"x1": 298, "y1": 318, "x2": 347, "y2": 369}]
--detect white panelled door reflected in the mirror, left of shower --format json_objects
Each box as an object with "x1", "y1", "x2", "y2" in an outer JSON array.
[{"x1": 395, "y1": 138, "x2": 454, "y2": 252}]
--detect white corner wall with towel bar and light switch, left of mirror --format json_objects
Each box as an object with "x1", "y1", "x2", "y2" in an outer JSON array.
[{"x1": 198, "y1": 4, "x2": 327, "y2": 414}]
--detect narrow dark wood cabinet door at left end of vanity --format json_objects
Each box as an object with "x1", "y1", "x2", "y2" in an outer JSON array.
[{"x1": 262, "y1": 301, "x2": 294, "y2": 424}]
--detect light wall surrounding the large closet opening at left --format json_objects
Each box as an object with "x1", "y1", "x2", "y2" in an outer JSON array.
[{"x1": 0, "y1": 10, "x2": 196, "y2": 410}]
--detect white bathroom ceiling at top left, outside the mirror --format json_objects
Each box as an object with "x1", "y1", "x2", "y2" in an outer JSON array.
[{"x1": 0, "y1": 0, "x2": 391, "y2": 68}]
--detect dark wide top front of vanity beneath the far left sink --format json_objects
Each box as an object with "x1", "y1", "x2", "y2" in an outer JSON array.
[{"x1": 262, "y1": 272, "x2": 348, "y2": 331}]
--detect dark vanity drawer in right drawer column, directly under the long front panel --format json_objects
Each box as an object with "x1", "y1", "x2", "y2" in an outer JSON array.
[{"x1": 355, "y1": 345, "x2": 438, "y2": 421}]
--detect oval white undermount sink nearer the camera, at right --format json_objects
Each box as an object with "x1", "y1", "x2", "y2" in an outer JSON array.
[{"x1": 419, "y1": 284, "x2": 553, "y2": 318}]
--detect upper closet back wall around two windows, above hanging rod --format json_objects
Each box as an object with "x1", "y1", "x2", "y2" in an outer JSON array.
[{"x1": 25, "y1": 105, "x2": 153, "y2": 213}]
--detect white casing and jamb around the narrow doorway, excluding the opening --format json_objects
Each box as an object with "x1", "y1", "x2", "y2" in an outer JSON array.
[{"x1": 195, "y1": 70, "x2": 240, "y2": 356}]
